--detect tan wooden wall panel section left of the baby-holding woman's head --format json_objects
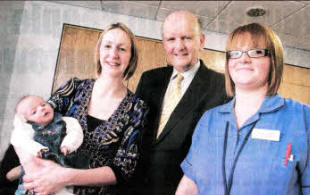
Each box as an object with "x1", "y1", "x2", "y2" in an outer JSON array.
[{"x1": 52, "y1": 24, "x2": 101, "y2": 92}]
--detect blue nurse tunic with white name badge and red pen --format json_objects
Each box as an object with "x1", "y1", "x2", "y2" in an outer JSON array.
[{"x1": 181, "y1": 95, "x2": 310, "y2": 195}]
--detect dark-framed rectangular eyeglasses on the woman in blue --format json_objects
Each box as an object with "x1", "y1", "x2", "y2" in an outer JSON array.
[{"x1": 226, "y1": 49, "x2": 269, "y2": 59}]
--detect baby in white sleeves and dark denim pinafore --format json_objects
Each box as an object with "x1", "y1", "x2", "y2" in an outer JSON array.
[{"x1": 11, "y1": 95, "x2": 88, "y2": 194}]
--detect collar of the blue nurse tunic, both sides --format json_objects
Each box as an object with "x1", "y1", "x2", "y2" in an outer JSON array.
[{"x1": 219, "y1": 94, "x2": 284, "y2": 113}]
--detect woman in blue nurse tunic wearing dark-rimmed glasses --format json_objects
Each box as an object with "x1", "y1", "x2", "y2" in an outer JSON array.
[{"x1": 177, "y1": 23, "x2": 310, "y2": 195}]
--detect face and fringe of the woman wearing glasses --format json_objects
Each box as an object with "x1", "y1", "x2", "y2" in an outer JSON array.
[{"x1": 226, "y1": 32, "x2": 272, "y2": 99}]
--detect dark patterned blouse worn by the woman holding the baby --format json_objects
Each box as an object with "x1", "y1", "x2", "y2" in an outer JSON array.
[{"x1": 48, "y1": 78, "x2": 148, "y2": 194}]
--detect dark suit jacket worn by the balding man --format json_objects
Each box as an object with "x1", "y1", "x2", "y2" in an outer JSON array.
[{"x1": 134, "y1": 61, "x2": 226, "y2": 195}]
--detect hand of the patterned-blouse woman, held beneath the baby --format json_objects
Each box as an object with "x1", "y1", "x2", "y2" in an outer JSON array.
[{"x1": 23, "y1": 157, "x2": 66, "y2": 195}]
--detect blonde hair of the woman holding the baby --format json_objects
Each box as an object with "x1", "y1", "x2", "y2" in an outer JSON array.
[{"x1": 95, "y1": 22, "x2": 138, "y2": 80}]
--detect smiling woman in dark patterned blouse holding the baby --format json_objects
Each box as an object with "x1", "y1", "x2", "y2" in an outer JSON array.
[{"x1": 17, "y1": 23, "x2": 148, "y2": 194}]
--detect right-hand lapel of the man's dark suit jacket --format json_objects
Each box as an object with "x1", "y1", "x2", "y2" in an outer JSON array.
[{"x1": 155, "y1": 61, "x2": 208, "y2": 143}]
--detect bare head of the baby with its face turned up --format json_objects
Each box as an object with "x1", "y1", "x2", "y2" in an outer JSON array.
[{"x1": 15, "y1": 95, "x2": 54, "y2": 126}]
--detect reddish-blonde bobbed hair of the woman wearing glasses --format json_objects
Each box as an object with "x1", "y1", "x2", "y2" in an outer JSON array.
[{"x1": 225, "y1": 23, "x2": 284, "y2": 97}]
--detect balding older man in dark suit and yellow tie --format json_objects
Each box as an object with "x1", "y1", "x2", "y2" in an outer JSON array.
[{"x1": 135, "y1": 11, "x2": 226, "y2": 195}]
